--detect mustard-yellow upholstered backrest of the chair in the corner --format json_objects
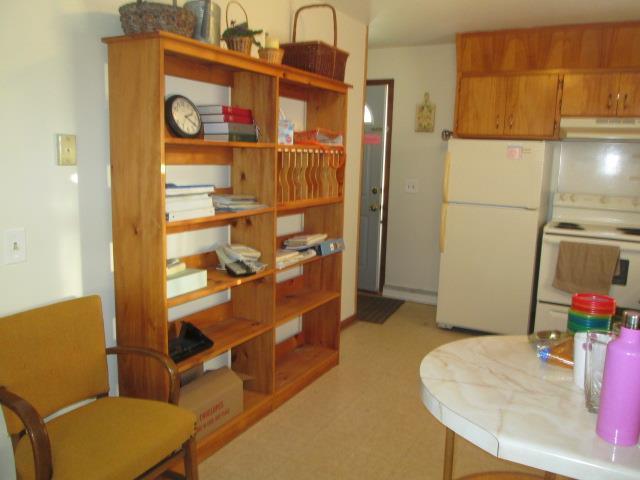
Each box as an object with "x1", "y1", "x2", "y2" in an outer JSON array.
[{"x1": 0, "y1": 295, "x2": 109, "y2": 434}]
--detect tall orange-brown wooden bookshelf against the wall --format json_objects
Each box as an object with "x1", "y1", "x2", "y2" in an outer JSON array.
[{"x1": 103, "y1": 32, "x2": 349, "y2": 459}]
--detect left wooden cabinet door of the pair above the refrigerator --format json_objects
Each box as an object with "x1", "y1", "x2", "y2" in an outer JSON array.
[{"x1": 456, "y1": 76, "x2": 505, "y2": 137}]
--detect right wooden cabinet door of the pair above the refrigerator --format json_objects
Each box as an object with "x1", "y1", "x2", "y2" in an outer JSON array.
[{"x1": 504, "y1": 75, "x2": 558, "y2": 137}]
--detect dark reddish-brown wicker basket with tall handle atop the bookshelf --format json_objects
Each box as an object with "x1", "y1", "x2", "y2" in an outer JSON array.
[{"x1": 280, "y1": 3, "x2": 349, "y2": 81}]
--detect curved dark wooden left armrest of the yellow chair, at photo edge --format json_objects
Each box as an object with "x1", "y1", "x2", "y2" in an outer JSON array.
[{"x1": 0, "y1": 386, "x2": 53, "y2": 480}]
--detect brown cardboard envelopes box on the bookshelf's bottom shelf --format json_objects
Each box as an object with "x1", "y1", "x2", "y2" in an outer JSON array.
[{"x1": 179, "y1": 367, "x2": 244, "y2": 439}]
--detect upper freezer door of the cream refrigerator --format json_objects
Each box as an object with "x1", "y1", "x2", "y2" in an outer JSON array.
[{"x1": 443, "y1": 139, "x2": 548, "y2": 209}]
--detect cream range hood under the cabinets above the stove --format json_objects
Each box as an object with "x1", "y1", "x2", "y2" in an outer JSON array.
[{"x1": 560, "y1": 117, "x2": 640, "y2": 140}]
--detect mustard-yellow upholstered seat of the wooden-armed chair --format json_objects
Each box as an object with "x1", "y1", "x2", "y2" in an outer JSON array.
[{"x1": 15, "y1": 397, "x2": 195, "y2": 480}]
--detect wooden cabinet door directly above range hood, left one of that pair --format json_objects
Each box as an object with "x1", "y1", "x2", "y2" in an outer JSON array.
[{"x1": 560, "y1": 73, "x2": 619, "y2": 117}]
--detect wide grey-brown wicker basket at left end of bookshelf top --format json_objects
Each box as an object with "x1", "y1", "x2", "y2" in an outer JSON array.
[{"x1": 119, "y1": 0, "x2": 196, "y2": 37}]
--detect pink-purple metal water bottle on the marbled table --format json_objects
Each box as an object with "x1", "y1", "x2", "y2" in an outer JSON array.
[{"x1": 596, "y1": 310, "x2": 640, "y2": 446}]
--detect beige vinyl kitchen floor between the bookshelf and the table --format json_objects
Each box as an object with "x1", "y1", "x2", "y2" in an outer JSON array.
[{"x1": 200, "y1": 303, "x2": 541, "y2": 480}]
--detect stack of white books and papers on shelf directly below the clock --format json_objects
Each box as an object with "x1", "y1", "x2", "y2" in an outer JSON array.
[{"x1": 165, "y1": 183, "x2": 216, "y2": 222}]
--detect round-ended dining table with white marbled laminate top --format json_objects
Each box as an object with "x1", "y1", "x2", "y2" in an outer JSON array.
[{"x1": 420, "y1": 335, "x2": 640, "y2": 480}]
